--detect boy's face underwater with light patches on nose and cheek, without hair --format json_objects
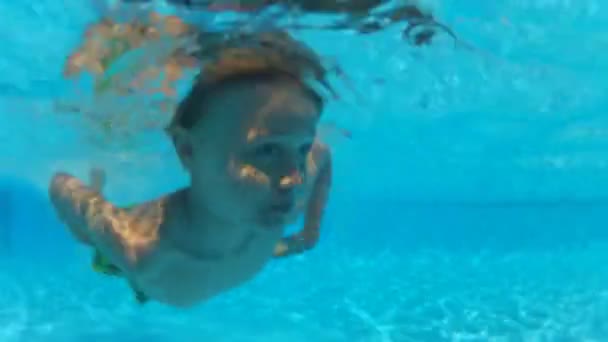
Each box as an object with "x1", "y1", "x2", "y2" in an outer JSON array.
[{"x1": 186, "y1": 80, "x2": 319, "y2": 228}]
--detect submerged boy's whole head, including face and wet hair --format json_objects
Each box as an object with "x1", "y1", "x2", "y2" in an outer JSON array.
[{"x1": 168, "y1": 33, "x2": 334, "y2": 228}]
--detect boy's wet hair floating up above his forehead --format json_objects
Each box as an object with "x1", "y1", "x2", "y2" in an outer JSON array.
[{"x1": 167, "y1": 31, "x2": 335, "y2": 135}]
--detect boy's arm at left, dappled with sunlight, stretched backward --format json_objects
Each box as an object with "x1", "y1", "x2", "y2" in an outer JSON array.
[{"x1": 49, "y1": 173, "x2": 139, "y2": 270}]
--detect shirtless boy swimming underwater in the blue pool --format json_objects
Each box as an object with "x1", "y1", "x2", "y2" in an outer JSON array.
[{"x1": 49, "y1": 32, "x2": 331, "y2": 307}]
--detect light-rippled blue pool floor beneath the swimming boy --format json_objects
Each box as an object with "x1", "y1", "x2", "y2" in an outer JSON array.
[{"x1": 0, "y1": 245, "x2": 608, "y2": 342}]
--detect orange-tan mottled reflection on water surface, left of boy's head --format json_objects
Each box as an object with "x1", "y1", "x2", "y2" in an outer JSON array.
[{"x1": 63, "y1": 13, "x2": 198, "y2": 97}]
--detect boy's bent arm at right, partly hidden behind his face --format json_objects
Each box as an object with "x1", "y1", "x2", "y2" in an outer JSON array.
[{"x1": 274, "y1": 151, "x2": 332, "y2": 257}]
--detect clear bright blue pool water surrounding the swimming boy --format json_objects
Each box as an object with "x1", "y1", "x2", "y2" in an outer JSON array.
[{"x1": 0, "y1": 0, "x2": 608, "y2": 342}]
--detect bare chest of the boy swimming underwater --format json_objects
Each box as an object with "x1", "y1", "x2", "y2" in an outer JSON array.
[{"x1": 119, "y1": 201, "x2": 280, "y2": 306}]
